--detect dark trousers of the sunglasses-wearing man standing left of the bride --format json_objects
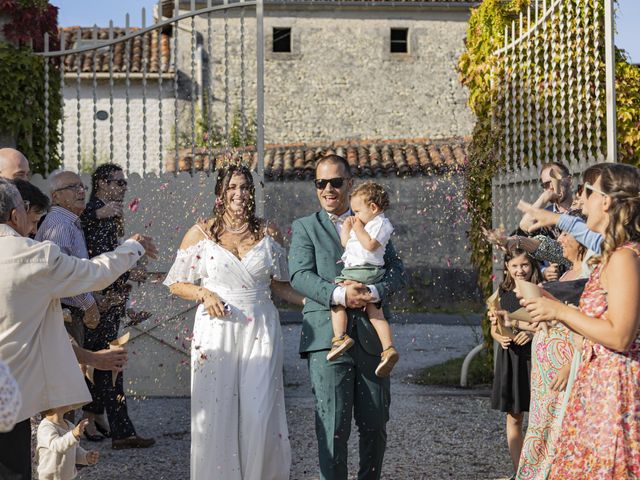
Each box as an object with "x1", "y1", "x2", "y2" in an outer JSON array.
[{"x1": 82, "y1": 307, "x2": 136, "y2": 440}]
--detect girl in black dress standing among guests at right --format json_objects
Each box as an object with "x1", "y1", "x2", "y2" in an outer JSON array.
[{"x1": 489, "y1": 248, "x2": 542, "y2": 478}]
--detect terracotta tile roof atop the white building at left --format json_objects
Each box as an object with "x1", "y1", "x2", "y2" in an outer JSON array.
[{"x1": 59, "y1": 27, "x2": 172, "y2": 73}]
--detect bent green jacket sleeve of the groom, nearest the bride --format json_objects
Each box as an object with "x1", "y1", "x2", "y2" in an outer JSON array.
[{"x1": 289, "y1": 220, "x2": 336, "y2": 308}]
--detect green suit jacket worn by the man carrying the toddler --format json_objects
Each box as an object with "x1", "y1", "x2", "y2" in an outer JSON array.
[{"x1": 289, "y1": 210, "x2": 407, "y2": 355}]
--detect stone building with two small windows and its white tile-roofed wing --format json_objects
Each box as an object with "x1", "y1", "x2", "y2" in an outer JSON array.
[{"x1": 62, "y1": 0, "x2": 479, "y2": 172}]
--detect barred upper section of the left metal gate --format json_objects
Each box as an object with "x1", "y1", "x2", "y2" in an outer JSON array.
[{"x1": 40, "y1": 0, "x2": 264, "y2": 198}]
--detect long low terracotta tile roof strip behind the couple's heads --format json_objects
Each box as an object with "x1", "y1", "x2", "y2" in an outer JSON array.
[{"x1": 166, "y1": 138, "x2": 469, "y2": 180}]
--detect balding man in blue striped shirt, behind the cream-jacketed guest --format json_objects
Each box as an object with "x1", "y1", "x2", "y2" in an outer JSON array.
[{"x1": 35, "y1": 172, "x2": 100, "y2": 345}]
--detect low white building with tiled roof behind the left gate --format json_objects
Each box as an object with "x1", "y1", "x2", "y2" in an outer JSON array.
[{"x1": 60, "y1": 27, "x2": 175, "y2": 172}]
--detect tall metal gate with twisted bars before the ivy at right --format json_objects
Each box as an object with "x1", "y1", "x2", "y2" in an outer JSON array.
[{"x1": 492, "y1": 0, "x2": 616, "y2": 231}]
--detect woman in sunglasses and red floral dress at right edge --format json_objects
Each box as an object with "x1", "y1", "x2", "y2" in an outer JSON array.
[{"x1": 522, "y1": 164, "x2": 640, "y2": 480}]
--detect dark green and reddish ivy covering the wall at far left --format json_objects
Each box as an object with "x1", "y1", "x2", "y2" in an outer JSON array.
[{"x1": 0, "y1": 0, "x2": 62, "y2": 173}]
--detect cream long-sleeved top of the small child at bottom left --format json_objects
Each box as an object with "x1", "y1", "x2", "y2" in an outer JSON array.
[{"x1": 36, "y1": 418, "x2": 87, "y2": 480}]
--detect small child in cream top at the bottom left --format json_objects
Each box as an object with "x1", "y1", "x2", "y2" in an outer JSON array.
[{"x1": 36, "y1": 407, "x2": 99, "y2": 480}]
